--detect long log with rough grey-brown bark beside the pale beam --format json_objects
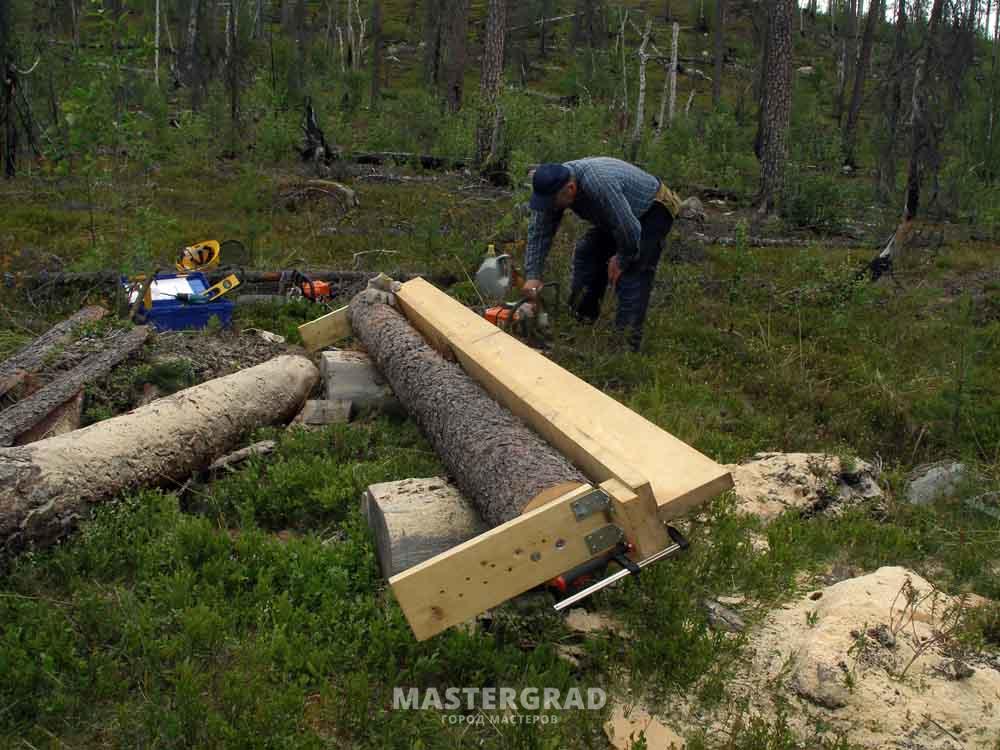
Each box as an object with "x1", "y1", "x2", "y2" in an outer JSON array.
[{"x1": 350, "y1": 294, "x2": 587, "y2": 527}]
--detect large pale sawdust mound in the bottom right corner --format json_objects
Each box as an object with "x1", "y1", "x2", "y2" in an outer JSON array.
[{"x1": 661, "y1": 567, "x2": 1000, "y2": 750}]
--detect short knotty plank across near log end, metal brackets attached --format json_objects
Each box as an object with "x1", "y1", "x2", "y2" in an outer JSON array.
[{"x1": 389, "y1": 485, "x2": 610, "y2": 641}]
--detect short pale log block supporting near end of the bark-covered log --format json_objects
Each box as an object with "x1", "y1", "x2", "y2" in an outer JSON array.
[{"x1": 362, "y1": 477, "x2": 489, "y2": 578}]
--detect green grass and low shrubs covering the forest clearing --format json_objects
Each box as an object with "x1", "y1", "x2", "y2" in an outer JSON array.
[{"x1": 0, "y1": 0, "x2": 1000, "y2": 749}]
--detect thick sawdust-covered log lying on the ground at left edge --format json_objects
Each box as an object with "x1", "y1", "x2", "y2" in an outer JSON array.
[{"x1": 0, "y1": 355, "x2": 319, "y2": 559}]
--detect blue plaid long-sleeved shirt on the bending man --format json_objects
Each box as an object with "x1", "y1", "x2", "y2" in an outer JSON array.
[{"x1": 524, "y1": 156, "x2": 660, "y2": 279}]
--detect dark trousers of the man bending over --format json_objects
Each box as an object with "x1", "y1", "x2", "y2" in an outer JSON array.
[{"x1": 570, "y1": 203, "x2": 673, "y2": 351}]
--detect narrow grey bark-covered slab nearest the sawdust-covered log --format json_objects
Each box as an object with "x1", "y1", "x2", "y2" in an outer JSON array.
[{"x1": 0, "y1": 326, "x2": 149, "y2": 446}]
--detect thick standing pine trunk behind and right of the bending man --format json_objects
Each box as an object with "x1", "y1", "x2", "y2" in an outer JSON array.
[{"x1": 758, "y1": 0, "x2": 795, "y2": 213}]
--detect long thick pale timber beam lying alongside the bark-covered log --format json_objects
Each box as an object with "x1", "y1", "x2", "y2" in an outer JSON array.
[{"x1": 396, "y1": 279, "x2": 732, "y2": 524}]
